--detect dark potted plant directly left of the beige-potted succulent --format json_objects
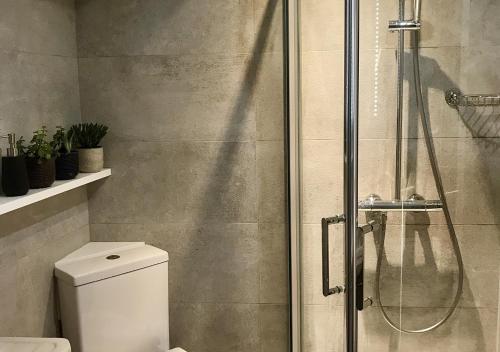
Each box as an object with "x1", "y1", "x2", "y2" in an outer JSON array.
[{"x1": 52, "y1": 126, "x2": 79, "y2": 180}]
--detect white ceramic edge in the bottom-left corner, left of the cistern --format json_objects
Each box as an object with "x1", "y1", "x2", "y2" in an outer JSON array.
[{"x1": 0, "y1": 337, "x2": 71, "y2": 352}]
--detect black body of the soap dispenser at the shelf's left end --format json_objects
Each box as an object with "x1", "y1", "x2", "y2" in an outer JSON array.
[{"x1": 2, "y1": 155, "x2": 30, "y2": 197}]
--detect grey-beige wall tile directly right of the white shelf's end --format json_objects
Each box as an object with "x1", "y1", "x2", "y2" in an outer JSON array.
[{"x1": 86, "y1": 136, "x2": 257, "y2": 223}]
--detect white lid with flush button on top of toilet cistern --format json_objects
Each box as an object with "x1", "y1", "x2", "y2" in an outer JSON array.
[{"x1": 55, "y1": 242, "x2": 168, "y2": 286}]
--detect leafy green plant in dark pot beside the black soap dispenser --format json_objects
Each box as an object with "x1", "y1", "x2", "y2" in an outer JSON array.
[{"x1": 18, "y1": 126, "x2": 56, "y2": 188}]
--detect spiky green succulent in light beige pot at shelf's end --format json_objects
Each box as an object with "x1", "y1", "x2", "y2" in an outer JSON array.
[{"x1": 70, "y1": 123, "x2": 108, "y2": 172}]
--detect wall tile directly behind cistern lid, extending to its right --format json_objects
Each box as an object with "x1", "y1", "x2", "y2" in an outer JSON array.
[{"x1": 92, "y1": 223, "x2": 262, "y2": 303}]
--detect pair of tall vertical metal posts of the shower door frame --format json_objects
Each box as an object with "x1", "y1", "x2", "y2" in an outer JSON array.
[{"x1": 283, "y1": 0, "x2": 363, "y2": 352}]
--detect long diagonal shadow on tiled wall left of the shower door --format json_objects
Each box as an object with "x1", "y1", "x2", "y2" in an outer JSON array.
[{"x1": 171, "y1": 0, "x2": 278, "y2": 351}]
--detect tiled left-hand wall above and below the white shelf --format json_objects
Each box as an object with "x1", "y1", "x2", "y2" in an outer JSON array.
[{"x1": 0, "y1": 0, "x2": 89, "y2": 337}]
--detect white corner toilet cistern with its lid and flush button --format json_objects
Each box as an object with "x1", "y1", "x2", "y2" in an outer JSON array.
[{"x1": 55, "y1": 242, "x2": 187, "y2": 352}]
